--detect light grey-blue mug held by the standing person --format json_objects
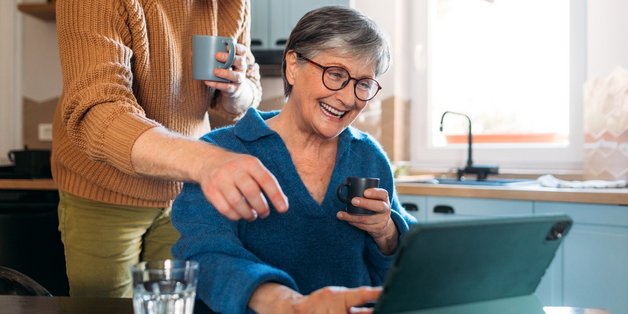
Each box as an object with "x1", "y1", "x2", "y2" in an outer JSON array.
[{"x1": 192, "y1": 35, "x2": 235, "y2": 82}]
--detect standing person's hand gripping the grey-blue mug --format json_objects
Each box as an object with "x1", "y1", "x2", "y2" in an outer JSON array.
[{"x1": 205, "y1": 43, "x2": 255, "y2": 114}]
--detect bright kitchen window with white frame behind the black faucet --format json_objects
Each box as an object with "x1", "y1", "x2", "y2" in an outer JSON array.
[{"x1": 410, "y1": 0, "x2": 586, "y2": 170}]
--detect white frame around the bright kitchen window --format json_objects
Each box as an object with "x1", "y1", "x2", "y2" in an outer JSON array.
[{"x1": 409, "y1": 0, "x2": 586, "y2": 170}]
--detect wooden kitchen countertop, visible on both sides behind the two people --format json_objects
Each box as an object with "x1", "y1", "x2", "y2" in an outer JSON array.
[{"x1": 0, "y1": 179, "x2": 628, "y2": 205}]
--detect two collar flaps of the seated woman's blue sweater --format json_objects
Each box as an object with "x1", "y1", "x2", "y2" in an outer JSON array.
[{"x1": 234, "y1": 108, "x2": 366, "y2": 147}]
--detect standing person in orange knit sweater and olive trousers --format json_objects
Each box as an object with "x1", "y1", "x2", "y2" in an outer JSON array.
[{"x1": 51, "y1": 0, "x2": 288, "y2": 297}]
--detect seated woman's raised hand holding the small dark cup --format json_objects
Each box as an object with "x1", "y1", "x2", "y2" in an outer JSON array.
[{"x1": 336, "y1": 188, "x2": 398, "y2": 255}]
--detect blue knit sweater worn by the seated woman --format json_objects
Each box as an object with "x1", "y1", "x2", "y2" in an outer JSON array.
[{"x1": 172, "y1": 109, "x2": 414, "y2": 314}]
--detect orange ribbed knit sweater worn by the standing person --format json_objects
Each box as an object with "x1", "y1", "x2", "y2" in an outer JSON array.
[{"x1": 52, "y1": 0, "x2": 261, "y2": 207}]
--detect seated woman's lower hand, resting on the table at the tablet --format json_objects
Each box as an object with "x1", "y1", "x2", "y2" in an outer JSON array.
[{"x1": 249, "y1": 282, "x2": 382, "y2": 314}]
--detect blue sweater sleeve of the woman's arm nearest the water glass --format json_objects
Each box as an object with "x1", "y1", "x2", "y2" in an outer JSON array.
[{"x1": 172, "y1": 184, "x2": 296, "y2": 313}]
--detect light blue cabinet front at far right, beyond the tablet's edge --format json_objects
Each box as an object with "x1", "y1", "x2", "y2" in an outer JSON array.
[{"x1": 535, "y1": 202, "x2": 628, "y2": 313}]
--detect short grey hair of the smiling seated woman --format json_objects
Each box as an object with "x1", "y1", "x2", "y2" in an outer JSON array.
[{"x1": 282, "y1": 6, "x2": 391, "y2": 97}]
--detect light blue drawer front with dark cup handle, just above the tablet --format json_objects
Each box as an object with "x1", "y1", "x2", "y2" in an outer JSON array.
[{"x1": 427, "y1": 196, "x2": 533, "y2": 221}]
